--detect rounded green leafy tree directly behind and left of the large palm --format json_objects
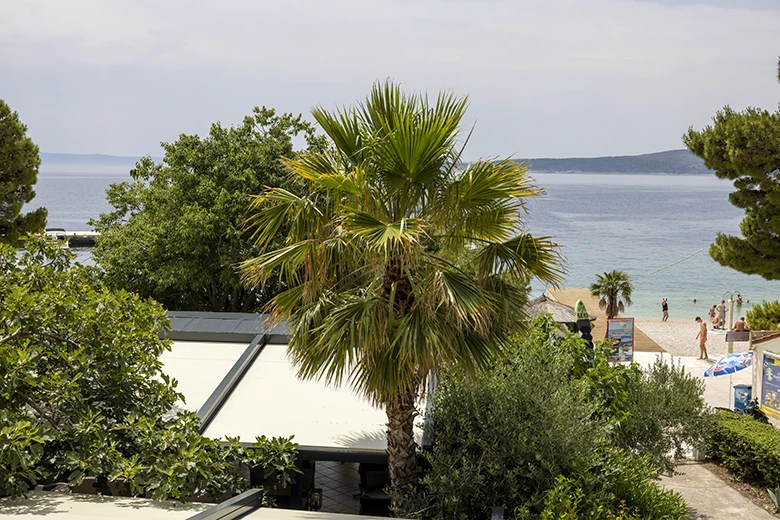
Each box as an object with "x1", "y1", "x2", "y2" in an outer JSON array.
[{"x1": 92, "y1": 108, "x2": 318, "y2": 312}]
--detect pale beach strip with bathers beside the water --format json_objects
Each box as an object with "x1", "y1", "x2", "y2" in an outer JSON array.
[{"x1": 635, "y1": 320, "x2": 747, "y2": 361}]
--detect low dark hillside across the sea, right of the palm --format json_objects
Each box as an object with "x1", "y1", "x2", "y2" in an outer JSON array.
[{"x1": 518, "y1": 150, "x2": 713, "y2": 175}]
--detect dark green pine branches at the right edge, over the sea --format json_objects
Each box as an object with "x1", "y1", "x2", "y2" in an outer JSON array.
[{"x1": 683, "y1": 61, "x2": 780, "y2": 280}]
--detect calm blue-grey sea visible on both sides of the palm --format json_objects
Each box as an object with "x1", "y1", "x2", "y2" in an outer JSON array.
[{"x1": 26, "y1": 173, "x2": 780, "y2": 321}]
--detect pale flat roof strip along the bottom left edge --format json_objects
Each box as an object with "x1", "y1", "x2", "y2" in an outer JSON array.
[{"x1": 0, "y1": 491, "x2": 214, "y2": 520}]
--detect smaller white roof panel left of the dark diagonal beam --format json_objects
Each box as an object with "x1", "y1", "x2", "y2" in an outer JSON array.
[{"x1": 160, "y1": 341, "x2": 244, "y2": 412}]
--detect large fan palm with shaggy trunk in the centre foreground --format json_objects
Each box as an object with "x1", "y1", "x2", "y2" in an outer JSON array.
[{"x1": 242, "y1": 82, "x2": 562, "y2": 506}]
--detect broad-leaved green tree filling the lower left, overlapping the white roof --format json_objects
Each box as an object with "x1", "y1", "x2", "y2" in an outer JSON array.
[{"x1": 0, "y1": 239, "x2": 296, "y2": 500}]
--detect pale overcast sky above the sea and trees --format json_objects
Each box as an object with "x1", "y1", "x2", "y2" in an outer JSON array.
[{"x1": 0, "y1": 0, "x2": 780, "y2": 159}]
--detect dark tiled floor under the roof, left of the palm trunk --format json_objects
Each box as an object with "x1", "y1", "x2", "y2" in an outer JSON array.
[{"x1": 314, "y1": 461, "x2": 360, "y2": 515}]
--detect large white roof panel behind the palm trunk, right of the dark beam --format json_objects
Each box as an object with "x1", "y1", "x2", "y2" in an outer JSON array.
[{"x1": 204, "y1": 345, "x2": 422, "y2": 453}]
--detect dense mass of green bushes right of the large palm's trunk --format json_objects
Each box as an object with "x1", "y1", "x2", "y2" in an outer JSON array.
[{"x1": 401, "y1": 317, "x2": 705, "y2": 519}]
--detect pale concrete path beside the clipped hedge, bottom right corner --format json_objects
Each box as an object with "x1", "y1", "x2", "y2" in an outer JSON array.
[{"x1": 661, "y1": 462, "x2": 777, "y2": 520}]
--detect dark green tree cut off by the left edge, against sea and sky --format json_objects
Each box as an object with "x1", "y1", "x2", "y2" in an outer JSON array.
[{"x1": 0, "y1": 99, "x2": 46, "y2": 245}]
